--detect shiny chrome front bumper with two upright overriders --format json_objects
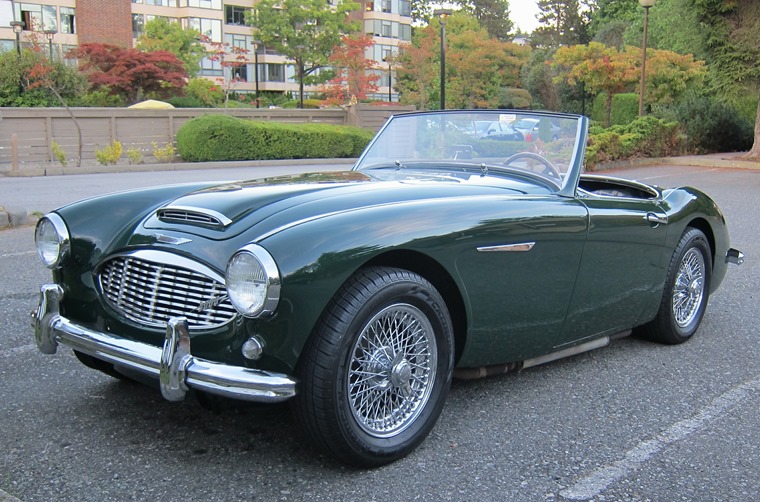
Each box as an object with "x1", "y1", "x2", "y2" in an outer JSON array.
[{"x1": 32, "y1": 284, "x2": 296, "y2": 403}]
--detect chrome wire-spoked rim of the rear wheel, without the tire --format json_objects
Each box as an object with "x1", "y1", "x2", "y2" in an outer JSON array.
[{"x1": 673, "y1": 248, "x2": 705, "y2": 328}]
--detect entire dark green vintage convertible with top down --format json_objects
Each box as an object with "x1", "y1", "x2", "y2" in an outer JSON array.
[{"x1": 33, "y1": 111, "x2": 743, "y2": 467}]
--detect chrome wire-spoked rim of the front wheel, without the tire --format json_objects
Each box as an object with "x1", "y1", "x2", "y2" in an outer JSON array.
[{"x1": 347, "y1": 303, "x2": 437, "y2": 438}]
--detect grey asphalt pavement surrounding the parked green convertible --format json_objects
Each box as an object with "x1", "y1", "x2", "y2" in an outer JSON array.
[{"x1": 0, "y1": 159, "x2": 760, "y2": 502}]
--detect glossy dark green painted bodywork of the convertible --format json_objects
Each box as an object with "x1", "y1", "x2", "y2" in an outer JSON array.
[{"x1": 47, "y1": 165, "x2": 728, "y2": 373}]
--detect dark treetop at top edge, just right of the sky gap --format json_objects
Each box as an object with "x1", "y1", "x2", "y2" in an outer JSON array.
[{"x1": 532, "y1": 0, "x2": 589, "y2": 47}]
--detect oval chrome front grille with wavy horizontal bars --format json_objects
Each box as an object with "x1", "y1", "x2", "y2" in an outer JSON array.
[{"x1": 98, "y1": 252, "x2": 237, "y2": 329}]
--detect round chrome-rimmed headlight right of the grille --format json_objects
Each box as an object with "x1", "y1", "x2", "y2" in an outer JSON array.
[{"x1": 225, "y1": 244, "x2": 280, "y2": 317}]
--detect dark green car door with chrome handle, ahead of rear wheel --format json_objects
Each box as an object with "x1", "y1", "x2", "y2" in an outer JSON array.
[{"x1": 555, "y1": 192, "x2": 667, "y2": 349}]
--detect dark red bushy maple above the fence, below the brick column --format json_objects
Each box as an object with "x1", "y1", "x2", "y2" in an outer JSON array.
[{"x1": 73, "y1": 44, "x2": 187, "y2": 103}]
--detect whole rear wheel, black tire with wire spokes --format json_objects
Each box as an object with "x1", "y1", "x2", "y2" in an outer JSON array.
[{"x1": 641, "y1": 227, "x2": 712, "y2": 345}]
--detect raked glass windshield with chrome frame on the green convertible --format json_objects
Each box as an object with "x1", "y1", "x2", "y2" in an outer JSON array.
[{"x1": 354, "y1": 110, "x2": 585, "y2": 189}]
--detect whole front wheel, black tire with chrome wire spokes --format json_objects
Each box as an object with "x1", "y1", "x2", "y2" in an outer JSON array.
[{"x1": 293, "y1": 267, "x2": 454, "y2": 467}]
